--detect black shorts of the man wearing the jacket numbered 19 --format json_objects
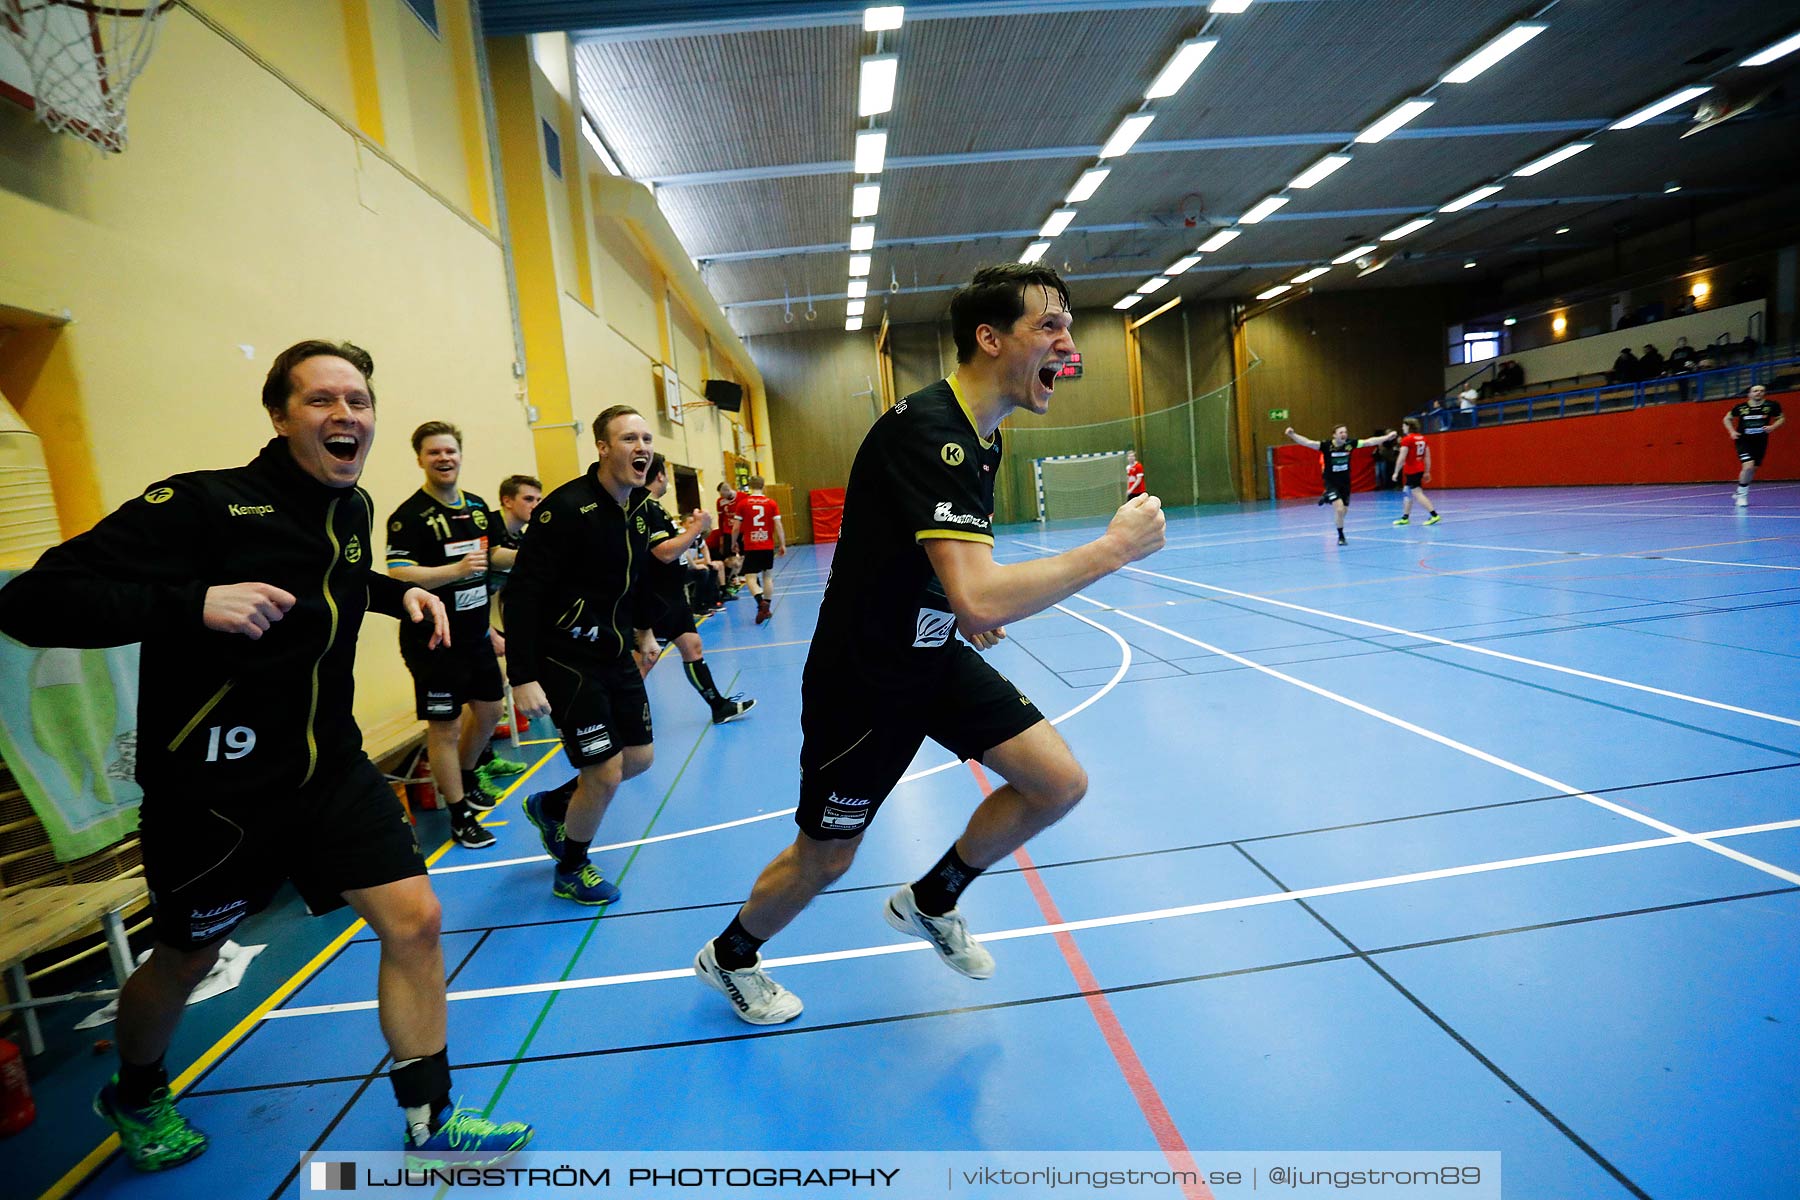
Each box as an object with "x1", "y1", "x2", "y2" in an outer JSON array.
[{"x1": 139, "y1": 757, "x2": 425, "y2": 950}]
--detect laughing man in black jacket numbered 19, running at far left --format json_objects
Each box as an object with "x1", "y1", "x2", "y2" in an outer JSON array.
[{"x1": 0, "y1": 342, "x2": 531, "y2": 1171}]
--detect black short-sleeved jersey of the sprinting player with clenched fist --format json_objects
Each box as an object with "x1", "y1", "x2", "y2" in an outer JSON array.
[{"x1": 806, "y1": 380, "x2": 1001, "y2": 685}]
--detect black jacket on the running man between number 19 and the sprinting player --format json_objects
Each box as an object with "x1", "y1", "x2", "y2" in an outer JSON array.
[{"x1": 500, "y1": 464, "x2": 657, "y2": 685}]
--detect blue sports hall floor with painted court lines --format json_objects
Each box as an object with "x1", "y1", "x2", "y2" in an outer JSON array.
[{"x1": 17, "y1": 484, "x2": 1800, "y2": 1200}]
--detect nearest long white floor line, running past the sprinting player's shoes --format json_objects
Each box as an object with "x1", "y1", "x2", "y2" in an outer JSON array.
[{"x1": 263, "y1": 819, "x2": 1800, "y2": 1020}]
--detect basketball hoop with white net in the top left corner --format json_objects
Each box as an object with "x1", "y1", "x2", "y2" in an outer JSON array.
[{"x1": 0, "y1": 0, "x2": 176, "y2": 153}]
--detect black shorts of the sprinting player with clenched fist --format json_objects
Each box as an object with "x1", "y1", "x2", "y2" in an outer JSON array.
[{"x1": 794, "y1": 642, "x2": 1044, "y2": 840}]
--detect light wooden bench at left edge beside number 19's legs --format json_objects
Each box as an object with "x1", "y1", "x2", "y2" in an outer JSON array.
[{"x1": 0, "y1": 878, "x2": 149, "y2": 1054}]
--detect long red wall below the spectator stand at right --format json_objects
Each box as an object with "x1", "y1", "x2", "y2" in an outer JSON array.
[{"x1": 1425, "y1": 392, "x2": 1800, "y2": 495}]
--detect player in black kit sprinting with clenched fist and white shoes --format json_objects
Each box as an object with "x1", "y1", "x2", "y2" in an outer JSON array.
[{"x1": 695, "y1": 263, "x2": 1163, "y2": 1025}]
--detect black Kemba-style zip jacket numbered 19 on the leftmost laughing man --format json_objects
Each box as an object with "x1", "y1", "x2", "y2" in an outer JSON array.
[{"x1": 0, "y1": 437, "x2": 407, "y2": 806}]
